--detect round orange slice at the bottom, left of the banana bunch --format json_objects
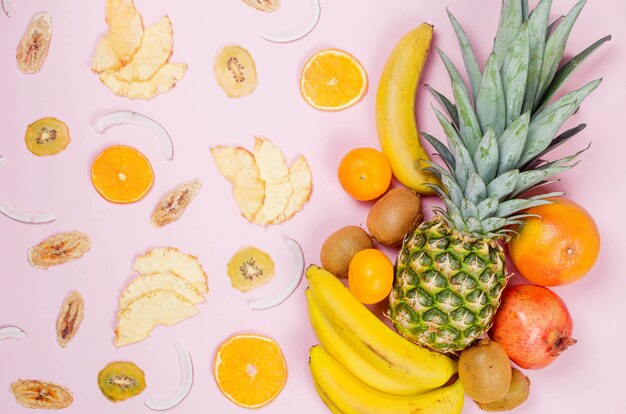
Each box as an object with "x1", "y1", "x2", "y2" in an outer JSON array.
[{"x1": 213, "y1": 335, "x2": 287, "y2": 408}]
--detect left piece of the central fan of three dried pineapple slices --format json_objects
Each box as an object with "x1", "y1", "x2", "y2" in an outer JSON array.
[{"x1": 211, "y1": 146, "x2": 265, "y2": 221}]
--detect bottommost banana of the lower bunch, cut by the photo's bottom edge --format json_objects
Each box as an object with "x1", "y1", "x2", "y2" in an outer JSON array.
[{"x1": 309, "y1": 345, "x2": 465, "y2": 414}]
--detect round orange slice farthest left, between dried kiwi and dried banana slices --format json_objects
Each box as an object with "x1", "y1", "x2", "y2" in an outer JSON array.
[{"x1": 91, "y1": 145, "x2": 154, "y2": 204}]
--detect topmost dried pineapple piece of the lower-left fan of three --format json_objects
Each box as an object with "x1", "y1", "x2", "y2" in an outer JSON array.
[{"x1": 134, "y1": 247, "x2": 209, "y2": 293}]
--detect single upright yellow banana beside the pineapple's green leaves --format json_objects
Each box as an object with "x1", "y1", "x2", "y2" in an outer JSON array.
[{"x1": 376, "y1": 23, "x2": 439, "y2": 195}]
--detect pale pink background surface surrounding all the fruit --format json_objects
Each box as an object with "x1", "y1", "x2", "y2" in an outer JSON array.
[{"x1": 0, "y1": 0, "x2": 626, "y2": 414}]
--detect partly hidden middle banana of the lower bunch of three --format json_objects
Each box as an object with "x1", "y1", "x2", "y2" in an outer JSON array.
[{"x1": 304, "y1": 290, "x2": 430, "y2": 395}]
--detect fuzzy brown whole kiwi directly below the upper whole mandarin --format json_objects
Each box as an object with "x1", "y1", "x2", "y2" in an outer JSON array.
[{"x1": 367, "y1": 188, "x2": 422, "y2": 246}]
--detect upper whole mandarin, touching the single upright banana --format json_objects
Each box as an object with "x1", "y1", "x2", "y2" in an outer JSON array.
[{"x1": 337, "y1": 148, "x2": 391, "y2": 201}]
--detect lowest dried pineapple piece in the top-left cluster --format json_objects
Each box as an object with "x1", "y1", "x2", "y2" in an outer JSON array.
[{"x1": 100, "y1": 63, "x2": 187, "y2": 100}]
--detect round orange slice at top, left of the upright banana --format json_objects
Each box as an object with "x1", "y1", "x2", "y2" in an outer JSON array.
[{"x1": 300, "y1": 49, "x2": 367, "y2": 111}]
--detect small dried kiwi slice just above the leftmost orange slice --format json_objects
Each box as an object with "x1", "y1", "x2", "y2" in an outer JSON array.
[{"x1": 25, "y1": 117, "x2": 70, "y2": 157}]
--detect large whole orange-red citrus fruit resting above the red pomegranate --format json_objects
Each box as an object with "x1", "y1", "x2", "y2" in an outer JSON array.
[{"x1": 508, "y1": 198, "x2": 600, "y2": 286}]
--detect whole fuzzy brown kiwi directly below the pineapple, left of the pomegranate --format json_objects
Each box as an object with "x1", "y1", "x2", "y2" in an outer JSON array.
[{"x1": 458, "y1": 338, "x2": 512, "y2": 404}]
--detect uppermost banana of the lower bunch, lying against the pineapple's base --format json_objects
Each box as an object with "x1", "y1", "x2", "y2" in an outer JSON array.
[{"x1": 306, "y1": 265, "x2": 457, "y2": 388}]
